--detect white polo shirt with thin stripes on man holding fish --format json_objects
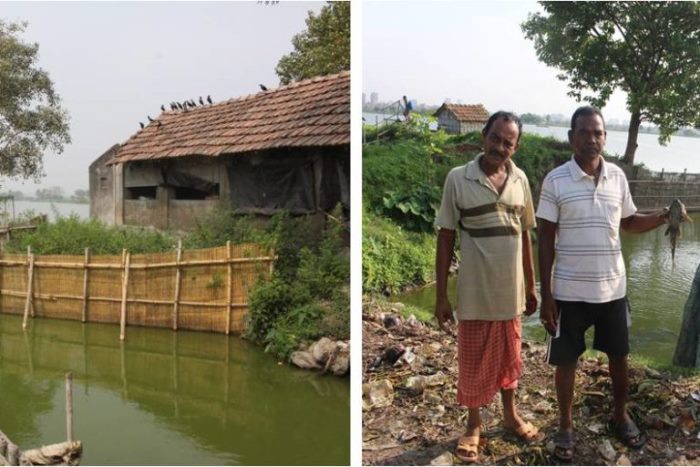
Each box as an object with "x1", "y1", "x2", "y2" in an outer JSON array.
[{"x1": 537, "y1": 157, "x2": 637, "y2": 303}]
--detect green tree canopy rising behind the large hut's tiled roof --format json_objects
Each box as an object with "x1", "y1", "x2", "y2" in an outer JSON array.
[{"x1": 275, "y1": 2, "x2": 350, "y2": 84}]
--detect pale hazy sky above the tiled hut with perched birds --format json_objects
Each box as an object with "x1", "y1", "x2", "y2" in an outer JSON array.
[{"x1": 0, "y1": 1, "x2": 324, "y2": 195}]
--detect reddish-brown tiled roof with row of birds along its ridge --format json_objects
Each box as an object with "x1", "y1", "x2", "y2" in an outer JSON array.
[{"x1": 110, "y1": 71, "x2": 350, "y2": 164}]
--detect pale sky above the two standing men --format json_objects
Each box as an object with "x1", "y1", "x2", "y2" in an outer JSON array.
[{"x1": 362, "y1": 1, "x2": 629, "y2": 121}]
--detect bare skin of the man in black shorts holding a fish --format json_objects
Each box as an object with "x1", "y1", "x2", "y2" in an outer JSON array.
[{"x1": 537, "y1": 114, "x2": 667, "y2": 454}]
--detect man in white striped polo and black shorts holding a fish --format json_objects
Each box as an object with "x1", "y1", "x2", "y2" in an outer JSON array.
[{"x1": 537, "y1": 106, "x2": 666, "y2": 461}]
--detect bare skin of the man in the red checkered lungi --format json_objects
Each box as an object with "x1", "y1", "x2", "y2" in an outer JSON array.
[{"x1": 435, "y1": 119, "x2": 537, "y2": 454}]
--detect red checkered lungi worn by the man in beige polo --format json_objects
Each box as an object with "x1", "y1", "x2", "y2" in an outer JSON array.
[{"x1": 457, "y1": 317, "x2": 523, "y2": 408}]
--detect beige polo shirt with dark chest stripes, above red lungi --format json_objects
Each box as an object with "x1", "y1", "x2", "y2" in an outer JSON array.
[{"x1": 435, "y1": 154, "x2": 535, "y2": 321}]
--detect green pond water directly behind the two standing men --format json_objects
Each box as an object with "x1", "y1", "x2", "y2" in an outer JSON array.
[{"x1": 392, "y1": 213, "x2": 700, "y2": 365}]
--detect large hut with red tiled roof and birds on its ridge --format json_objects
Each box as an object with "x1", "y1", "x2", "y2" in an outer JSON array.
[{"x1": 90, "y1": 72, "x2": 350, "y2": 229}]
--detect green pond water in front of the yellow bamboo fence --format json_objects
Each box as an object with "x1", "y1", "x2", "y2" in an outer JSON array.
[{"x1": 0, "y1": 314, "x2": 350, "y2": 465}]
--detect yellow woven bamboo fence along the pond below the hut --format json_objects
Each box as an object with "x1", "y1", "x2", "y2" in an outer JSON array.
[{"x1": 0, "y1": 242, "x2": 274, "y2": 340}]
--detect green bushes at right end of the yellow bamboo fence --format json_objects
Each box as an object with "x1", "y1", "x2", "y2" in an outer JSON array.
[{"x1": 247, "y1": 207, "x2": 350, "y2": 358}]
